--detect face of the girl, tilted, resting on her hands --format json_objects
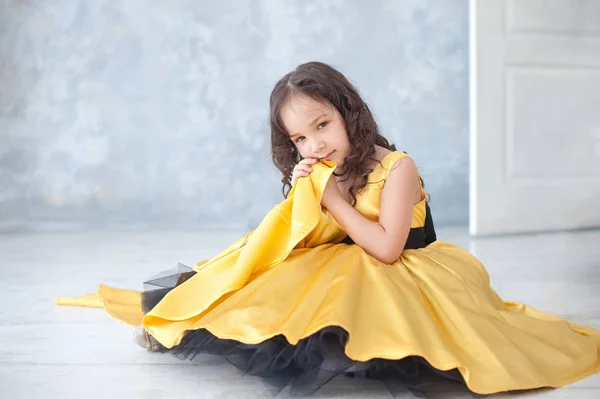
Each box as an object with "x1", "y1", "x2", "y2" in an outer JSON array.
[{"x1": 281, "y1": 96, "x2": 350, "y2": 167}]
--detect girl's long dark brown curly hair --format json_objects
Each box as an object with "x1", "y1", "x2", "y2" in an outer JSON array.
[{"x1": 270, "y1": 62, "x2": 396, "y2": 206}]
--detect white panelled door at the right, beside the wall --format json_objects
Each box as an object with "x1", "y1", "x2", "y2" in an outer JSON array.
[{"x1": 469, "y1": 0, "x2": 600, "y2": 235}]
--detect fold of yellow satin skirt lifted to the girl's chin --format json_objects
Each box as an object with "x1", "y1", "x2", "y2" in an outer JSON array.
[{"x1": 143, "y1": 162, "x2": 335, "y2": 347}]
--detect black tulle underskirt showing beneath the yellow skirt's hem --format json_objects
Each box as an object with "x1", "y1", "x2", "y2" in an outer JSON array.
[{"x1": 137, "y1": 265, "x2": 482, "y2": 397}]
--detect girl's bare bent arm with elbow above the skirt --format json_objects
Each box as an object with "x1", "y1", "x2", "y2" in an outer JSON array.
[{"x1": 321, "y1": 157, "x2": 420, "y2": 264}]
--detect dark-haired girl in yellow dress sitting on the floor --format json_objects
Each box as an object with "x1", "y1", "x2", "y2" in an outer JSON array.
[{"x1": 59, "y1": 62, "x2": 600, "y2": 394}]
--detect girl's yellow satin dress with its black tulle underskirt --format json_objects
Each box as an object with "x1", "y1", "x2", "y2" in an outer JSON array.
[{"x1": 57, "y1": 152, "x2": 600, "y2": 394}]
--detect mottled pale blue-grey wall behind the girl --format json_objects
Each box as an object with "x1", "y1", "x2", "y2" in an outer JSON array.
[{"x1": 0, "y1": 0, "x2": 468, "y2": 230}]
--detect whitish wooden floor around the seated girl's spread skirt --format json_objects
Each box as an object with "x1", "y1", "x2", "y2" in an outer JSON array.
[{"x1": 0, "y1": 230, "x2": 600, "y2": 399}]
